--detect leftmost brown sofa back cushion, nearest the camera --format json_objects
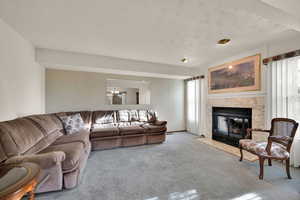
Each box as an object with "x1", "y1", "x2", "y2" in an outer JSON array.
[{"x1": 0, "y1": 118, "x2": 45, "y2": 158}]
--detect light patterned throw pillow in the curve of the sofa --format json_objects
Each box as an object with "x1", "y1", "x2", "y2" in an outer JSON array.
[{"x1": 59, "y1": 113, "x2": 85, "y2": 135}]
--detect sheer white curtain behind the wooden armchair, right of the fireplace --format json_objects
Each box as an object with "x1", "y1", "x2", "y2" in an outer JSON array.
[{"x1": 267, "y1": 57, "x2": 300, "y2": 166}]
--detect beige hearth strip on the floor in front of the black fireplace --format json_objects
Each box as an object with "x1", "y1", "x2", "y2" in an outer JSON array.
[{"x1": 197, "y1": 138, "x2": 258, "y2": 162}]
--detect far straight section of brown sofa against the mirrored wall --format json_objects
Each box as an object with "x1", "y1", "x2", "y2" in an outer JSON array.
[{"x1": 90, "y1": 110, "x2": 167, "y2": 150}]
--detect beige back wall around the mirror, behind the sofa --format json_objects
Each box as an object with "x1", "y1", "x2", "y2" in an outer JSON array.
[{"x1": 46, "y1": 69, "x2": 185, "y2": 131}]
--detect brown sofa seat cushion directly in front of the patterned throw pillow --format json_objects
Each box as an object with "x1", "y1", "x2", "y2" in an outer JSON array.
[{"x1": 53, "y1": 130, "x2": 90, "y2": 148}]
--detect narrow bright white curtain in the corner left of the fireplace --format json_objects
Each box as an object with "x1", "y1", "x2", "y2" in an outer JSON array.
[{"x1": 186, "y1": 79, "x2": 206, "y2": 135}]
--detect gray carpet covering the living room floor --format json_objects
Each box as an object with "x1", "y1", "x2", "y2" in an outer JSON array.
[{"x1": 37, "y1": 133, "x2": 300, "y2": 200}]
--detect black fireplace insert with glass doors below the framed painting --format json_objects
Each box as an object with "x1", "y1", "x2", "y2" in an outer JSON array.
[{"x1": 212, "y1": 107, "x2": 252, "y2": 146}]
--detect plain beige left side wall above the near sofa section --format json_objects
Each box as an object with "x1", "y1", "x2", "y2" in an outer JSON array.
[{"x1": 0, "y1": 19, "x2": 44, "y2": 121}]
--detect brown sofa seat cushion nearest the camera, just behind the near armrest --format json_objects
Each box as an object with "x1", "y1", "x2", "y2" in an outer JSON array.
[{"x1": 40, "y1": 142, "x2": 85, "y2": 173}]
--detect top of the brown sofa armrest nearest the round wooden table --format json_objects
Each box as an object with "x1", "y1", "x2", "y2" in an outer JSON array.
[{"x1": 5, "y1": 151, "x2": 66, "y2": 169}]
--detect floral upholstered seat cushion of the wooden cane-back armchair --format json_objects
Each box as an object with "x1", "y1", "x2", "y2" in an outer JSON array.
[{"x1": 240, "y1": 139, "x2": 290, "y2": 159}]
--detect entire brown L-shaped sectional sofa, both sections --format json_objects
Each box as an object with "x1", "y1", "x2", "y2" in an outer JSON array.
[{"x1": 0, "y1": 110, "x2": 167, "y2": 193}]
